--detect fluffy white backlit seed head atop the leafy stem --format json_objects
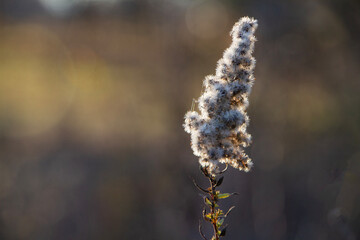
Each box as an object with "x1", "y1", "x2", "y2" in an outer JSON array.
[{"x1": 183, "y1": 17, "x2": 258, "y2": 175}]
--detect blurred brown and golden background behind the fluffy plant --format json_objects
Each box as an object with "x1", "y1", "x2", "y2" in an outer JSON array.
[{"x1": 0, "y1": 0, "x2": 360, "y2": 240}]
